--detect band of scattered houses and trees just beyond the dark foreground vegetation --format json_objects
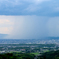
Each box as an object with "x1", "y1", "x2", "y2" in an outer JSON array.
[{"x1": 0, "y1": 45, "x2": 59, "y2": 53}]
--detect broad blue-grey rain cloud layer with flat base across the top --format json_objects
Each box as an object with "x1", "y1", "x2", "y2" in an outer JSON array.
[{"x1": 0, "y1": 0, "x2": 59, "y2": 16}]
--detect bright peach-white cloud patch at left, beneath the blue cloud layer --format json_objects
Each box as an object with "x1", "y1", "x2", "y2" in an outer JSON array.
[{"x1": 0, "y1": 16, "x2": 14, "y2": 34}]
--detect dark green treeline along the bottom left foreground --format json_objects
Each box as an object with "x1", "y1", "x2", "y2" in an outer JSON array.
[{"x1": 0, "y1": 53, "x2": 35, "y2": 59}]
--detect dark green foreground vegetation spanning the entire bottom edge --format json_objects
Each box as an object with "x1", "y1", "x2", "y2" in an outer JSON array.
[{"x1": 0, "y1": 50, "x2": 59, "y2": 59}]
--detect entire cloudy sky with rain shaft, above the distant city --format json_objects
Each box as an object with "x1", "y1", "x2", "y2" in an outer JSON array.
[{"x1": 0, "y1": 0, "x2": 59, "y2": 39}]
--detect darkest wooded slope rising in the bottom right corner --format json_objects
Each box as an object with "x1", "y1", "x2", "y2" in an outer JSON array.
[{"x1": 38, "y1": 50, "x2": 59, "y2": 59}]
